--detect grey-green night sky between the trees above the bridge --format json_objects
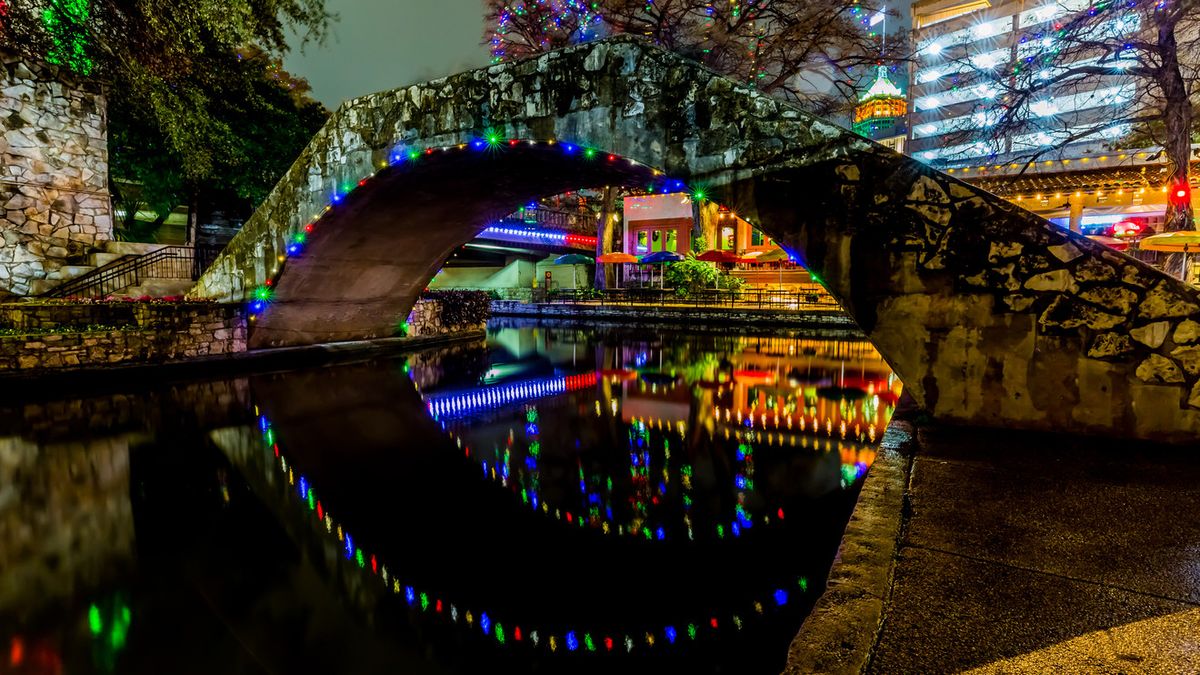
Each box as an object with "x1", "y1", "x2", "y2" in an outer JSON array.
[{"x1": 284, "y1": 0, "x2": 488, "y2": 109}]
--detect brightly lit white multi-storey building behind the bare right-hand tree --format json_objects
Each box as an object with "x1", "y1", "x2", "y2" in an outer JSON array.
[{"x1": 908, "y1": 0, "x2": 1140, "y2": 166}]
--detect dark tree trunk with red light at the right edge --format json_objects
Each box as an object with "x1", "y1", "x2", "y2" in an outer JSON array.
[{"x1": 1154, "y1": 7, "x2": 1195, "y2": 232}]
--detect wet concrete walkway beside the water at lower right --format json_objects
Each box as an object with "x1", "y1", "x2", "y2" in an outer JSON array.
[{"x1": 788, "y1": 413, "x2": 1200, "y2": 674}]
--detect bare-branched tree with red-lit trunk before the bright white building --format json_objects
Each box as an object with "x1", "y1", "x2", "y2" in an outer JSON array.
[{"x1": 950, "y1": 0, "x2": 1200, "y2": 231}]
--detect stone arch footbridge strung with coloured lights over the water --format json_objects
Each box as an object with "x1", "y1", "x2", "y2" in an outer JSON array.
[{"x1": 192, "y1": 37, "x2": 1200, "y2": 442}]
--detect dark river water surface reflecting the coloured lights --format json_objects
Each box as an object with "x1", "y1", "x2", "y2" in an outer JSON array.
[{"x1": 0, "y1": 324, "x2": 900, "y2": 674}]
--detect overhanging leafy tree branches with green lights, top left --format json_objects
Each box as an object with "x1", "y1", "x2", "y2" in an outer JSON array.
[{"x1": 0, "y1": 0, "x2": 334, "y2": 180}]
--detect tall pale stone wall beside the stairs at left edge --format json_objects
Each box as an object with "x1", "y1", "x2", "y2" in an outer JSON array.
[{"x1": 0, "y1": 52, "x2": 113, "y2": 297}]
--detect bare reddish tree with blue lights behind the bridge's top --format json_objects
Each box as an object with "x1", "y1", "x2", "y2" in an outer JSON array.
[{"x1": 485, "y1": 0, "x2": 904, "y2": 112}]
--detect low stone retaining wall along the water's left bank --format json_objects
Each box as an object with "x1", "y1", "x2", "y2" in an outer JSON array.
[{"x1": 0, "y1": 303, "x2": 246, "y2": 371}]
